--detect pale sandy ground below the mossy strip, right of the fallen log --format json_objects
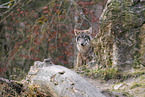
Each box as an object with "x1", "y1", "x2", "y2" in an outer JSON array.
[{"x1": 79, "y1": 68, "x2": 145, "y2": 97}]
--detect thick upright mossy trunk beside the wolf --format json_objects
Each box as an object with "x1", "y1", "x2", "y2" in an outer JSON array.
[{"x1": 93, "y1": 0, "x2": 145, "y2": 70}]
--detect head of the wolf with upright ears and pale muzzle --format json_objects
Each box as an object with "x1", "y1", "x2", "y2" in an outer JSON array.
[{"x1": 74, "y1": 27, "x2": 92, "y2": 54}]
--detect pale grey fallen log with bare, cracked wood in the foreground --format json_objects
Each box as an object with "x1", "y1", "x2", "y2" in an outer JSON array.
[{"x1": 27, "y1": 59, "x2": 105, "y2": 97}]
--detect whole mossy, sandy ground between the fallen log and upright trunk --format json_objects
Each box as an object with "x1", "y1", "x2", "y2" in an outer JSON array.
[{"x1": 77, "y1": 66, "x2": 145, "y2": 97}]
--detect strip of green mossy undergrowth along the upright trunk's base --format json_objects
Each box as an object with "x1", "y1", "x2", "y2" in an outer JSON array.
[{"x1": 76, "y1": 66, "x2": 145, "y2": 81}]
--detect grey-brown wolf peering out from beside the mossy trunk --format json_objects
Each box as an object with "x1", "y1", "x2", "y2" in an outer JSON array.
[{"x1": 74, "y1": 27, "x2": 96, "y2": 68}]
